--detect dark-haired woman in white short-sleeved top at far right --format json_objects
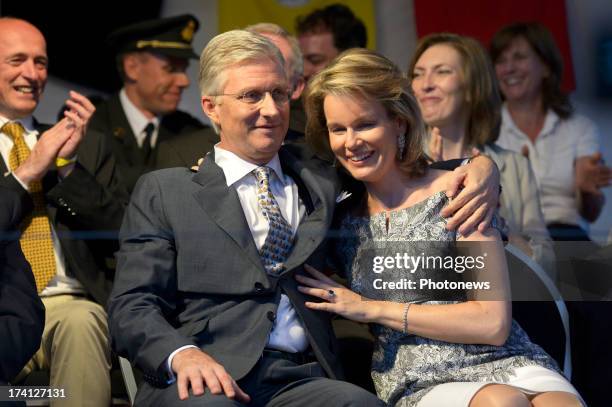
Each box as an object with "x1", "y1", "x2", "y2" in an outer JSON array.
[{"x1": 491, "y1": 23, "x2": 611, "y2": 240}]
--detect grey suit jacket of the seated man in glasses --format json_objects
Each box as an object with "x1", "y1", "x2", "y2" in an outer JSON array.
[{"x1": 109, "y1": 146, "x2": 341, "y2": 385}]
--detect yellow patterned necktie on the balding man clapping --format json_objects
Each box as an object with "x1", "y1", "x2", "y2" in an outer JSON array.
[{"x1": 2, "y1": 122, "x2": 56, "y2": 293}]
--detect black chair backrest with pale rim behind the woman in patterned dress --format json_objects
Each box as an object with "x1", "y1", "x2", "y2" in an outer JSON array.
[{"x1": 506, "y1": 244, "x2": 572, "y2": 379}]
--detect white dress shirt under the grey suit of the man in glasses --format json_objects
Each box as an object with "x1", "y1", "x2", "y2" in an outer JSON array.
[{"x1": 168, "y1": 145, "x2": 308, "y2": 377}]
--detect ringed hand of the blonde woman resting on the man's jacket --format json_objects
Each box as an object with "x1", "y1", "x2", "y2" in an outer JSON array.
[{"x1": 295, "y1": 264, "x2": 377, "y2": 322}]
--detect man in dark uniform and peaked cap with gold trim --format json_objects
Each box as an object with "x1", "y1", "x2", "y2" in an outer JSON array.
[{"x1": 90, "y1": 15, "x2": 204, "y2": 192}]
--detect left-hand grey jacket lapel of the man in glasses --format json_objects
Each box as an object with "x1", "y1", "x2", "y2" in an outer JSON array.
[{"x1": 193, "y1": 152, "x2": 265, "y2": 273}]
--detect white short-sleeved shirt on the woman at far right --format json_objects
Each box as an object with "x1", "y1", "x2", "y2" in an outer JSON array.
[{"x1": 497, "y1": 105, "x2": 599, "y2": 230}]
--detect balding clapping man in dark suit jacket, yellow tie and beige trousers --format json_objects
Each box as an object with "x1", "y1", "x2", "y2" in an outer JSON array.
[{"x1": 0, "y1": 18, "x2": 127, "y2": 406}]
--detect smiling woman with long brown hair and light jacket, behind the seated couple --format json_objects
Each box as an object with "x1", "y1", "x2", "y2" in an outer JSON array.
[{"x1": 408, "y1": 33, "x2": 554, "y2": 277}]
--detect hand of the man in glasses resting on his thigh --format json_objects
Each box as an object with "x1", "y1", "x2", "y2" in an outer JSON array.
[{"x1": 172, "y1": 348, "x2": 251, "y2": 403}]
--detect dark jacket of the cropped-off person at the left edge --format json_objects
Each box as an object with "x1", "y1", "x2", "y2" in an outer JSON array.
[{"x1": 0, "y1": 186, "x2": 45, "y2": 385}]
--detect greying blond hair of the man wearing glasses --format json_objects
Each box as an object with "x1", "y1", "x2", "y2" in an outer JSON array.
[{"x1": 198, "y1": 30, "x2": 285, "y2": 96}]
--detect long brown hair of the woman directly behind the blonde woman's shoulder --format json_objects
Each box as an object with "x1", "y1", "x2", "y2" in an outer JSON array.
[{"x1": 408, "y1": 33, "x2": 501, "y2": 146}]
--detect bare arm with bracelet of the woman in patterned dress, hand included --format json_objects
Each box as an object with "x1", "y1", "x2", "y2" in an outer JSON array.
[{"x1": 296, "y1": 228, "x2": 512, "y2": 346}]
